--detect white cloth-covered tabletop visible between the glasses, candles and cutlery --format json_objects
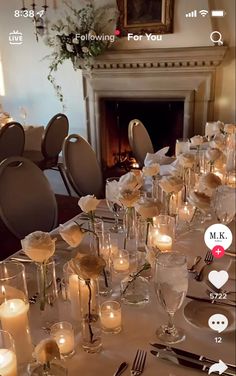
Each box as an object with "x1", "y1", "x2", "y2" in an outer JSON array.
[{"x1": 7, "y1": 200, "x2": 236, "y2": 376}]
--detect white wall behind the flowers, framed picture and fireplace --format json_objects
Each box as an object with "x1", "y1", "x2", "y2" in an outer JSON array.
[{"x1": 0, "y1": 0, "x2": 235, "y2": 135}]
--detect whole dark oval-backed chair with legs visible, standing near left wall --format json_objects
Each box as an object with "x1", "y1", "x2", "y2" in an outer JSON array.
[{"x1": 23, "y1": 114, "x2": 71, "y2": 195}]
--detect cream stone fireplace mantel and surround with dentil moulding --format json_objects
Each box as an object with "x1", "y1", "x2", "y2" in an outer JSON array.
[{"x1": 81, "y1": 46, "x2": 227, "y2": 164}]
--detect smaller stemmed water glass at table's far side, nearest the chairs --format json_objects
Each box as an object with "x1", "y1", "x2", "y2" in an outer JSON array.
[{"x1": 106, "y1": 177, "x2": 123, "y2": 233}]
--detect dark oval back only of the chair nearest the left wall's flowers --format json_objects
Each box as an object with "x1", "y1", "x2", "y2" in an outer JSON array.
[{"x1": 42, "y1": 114, "x2": 69, "y2": 159}]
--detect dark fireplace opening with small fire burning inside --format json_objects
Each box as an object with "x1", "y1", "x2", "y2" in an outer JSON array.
[{"x1": 100, "y1": 98, "x2": 184, "y2": 170}]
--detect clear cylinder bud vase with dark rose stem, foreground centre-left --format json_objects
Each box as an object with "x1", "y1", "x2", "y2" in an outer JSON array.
[{"x1": 79, "y1": 278, "x2": 102, "y2": 353}]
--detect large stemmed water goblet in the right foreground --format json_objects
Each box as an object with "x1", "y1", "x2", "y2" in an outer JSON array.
[{"x1": 154, "y1": 252, "x2": 188, "y2": 344}]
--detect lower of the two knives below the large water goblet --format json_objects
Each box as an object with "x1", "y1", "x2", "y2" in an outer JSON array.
[{"x1": 151, "y1": 350, "x2": 235, "y2": 376}]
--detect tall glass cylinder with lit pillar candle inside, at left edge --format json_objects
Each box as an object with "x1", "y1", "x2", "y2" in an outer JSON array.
[{"x1": 0, "y1": 261, "x2": 32, "y2": 363}]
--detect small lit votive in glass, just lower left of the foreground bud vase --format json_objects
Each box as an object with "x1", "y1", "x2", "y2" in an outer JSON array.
[{"x1": 50, "y1": 321, "x2": 75, "y2": 357}]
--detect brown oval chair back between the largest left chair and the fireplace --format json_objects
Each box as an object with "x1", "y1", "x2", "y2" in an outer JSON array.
[{"x1": 62, "y1": 134, "x2": 104, "y2": 198}]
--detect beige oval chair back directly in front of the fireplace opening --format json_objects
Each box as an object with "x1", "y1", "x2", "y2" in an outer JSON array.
[{"x1": 128, "y1": 119, "x2": 154, "y2": 167}]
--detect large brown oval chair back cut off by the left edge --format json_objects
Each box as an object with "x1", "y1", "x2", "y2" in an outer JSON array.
[{"x1": 0, "y1": 157, "x2": 57, "y2": 239}]
